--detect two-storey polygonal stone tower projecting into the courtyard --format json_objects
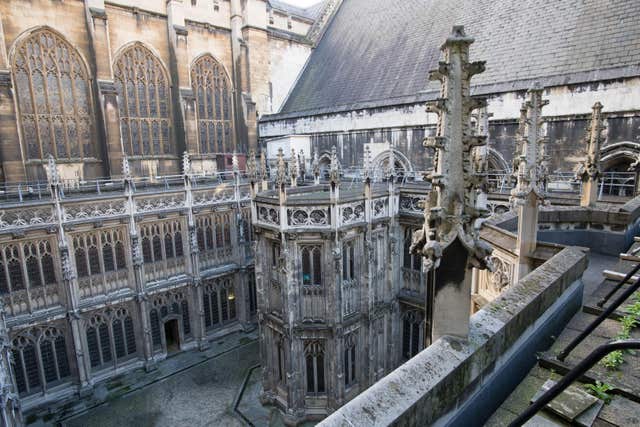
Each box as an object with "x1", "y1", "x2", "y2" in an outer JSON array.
[{"x1": 254, "y1": 176, "x2": 428, "y2": 424}]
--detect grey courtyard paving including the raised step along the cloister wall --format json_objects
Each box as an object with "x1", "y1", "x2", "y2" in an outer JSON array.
[{"x1": 43, "y1": 331, "x2": 259, "y2": 427}]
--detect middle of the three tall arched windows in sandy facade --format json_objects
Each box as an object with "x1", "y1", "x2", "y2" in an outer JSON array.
[{"x1": 114, "y1": 43, "x2": 175, "y2": 156}]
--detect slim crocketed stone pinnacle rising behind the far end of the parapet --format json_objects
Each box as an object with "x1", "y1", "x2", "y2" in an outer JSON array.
[{"x1": 511, "y1": 89, "x2": 549, "y2": 280}]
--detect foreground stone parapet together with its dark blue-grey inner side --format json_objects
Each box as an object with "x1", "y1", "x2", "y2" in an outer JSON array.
[{"x1": 319, "y1": 247, "x2": 587, "y2": 427}]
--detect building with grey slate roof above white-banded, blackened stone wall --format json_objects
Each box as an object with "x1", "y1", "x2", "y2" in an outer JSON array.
[{"x1": 259, "y1": 0, "x2": 640, "y2": 196}]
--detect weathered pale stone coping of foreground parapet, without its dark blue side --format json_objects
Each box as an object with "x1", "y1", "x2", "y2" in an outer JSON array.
[{"x1": 319, "y1": 247, "x2": 587, "y2": 427}]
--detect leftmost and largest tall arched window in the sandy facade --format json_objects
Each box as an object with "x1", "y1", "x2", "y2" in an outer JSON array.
[{"x1": 13, "y1": 29, "x2": 96, "y2": 160}]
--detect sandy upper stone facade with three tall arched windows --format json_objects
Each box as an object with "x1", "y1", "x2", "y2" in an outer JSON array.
[{"x1": 0, "y1": 0, "x2": 328, "y2": 183}]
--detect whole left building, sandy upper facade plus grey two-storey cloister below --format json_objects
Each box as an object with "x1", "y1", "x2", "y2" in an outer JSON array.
[{"x1": 0, "y1": 0, "x2": 337, "y2": 421}]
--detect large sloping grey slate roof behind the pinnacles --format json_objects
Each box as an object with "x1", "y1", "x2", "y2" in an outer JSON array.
[{"x1": 263, "y1": 0, "x2": 640, "y2": 120}]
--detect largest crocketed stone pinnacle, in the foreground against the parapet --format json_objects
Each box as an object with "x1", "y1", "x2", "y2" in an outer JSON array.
[{"x1": 412, "y1": 26, "x2": 491, "y2": 342}]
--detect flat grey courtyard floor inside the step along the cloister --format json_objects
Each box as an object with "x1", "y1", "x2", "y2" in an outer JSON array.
[{"x1": 61, "y1": 334, "x2": 260, "y2": 427}]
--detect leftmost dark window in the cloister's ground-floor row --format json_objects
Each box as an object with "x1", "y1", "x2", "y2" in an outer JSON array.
[{"x1": 12, "y1": 327, "x2": 71, "y2": 395}]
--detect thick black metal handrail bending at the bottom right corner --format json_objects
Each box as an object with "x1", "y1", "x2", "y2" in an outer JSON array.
[{"x1": 509, "y1": 339, "x2": 640, "y2": 427}]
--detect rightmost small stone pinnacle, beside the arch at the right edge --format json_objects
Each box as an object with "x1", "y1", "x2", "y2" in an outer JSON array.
[{"x1": 580, "y1": 102, "x2": 605, "y2": 208}]
